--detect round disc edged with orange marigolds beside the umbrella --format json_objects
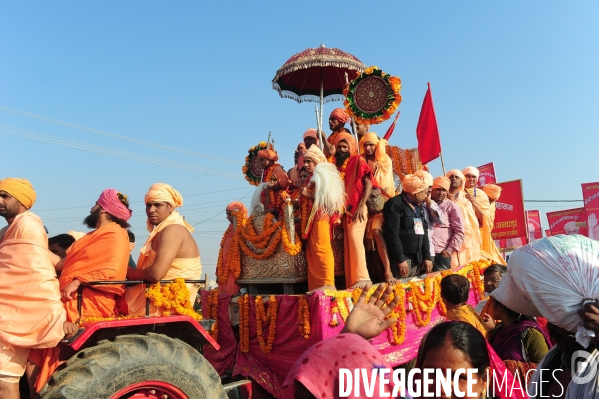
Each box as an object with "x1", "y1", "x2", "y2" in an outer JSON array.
[{"x1": 343, "y1": 66, "x2": 401, "y2": 125}]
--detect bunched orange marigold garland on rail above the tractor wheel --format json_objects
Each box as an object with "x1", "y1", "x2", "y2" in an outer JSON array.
[{"x1": 146, "y1": 278, "x2": 202, "y2": 320}]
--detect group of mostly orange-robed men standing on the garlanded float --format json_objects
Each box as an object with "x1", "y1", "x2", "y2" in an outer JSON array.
[{"x1": 217, "y1": 108, "x2": 505, "y2": 294}]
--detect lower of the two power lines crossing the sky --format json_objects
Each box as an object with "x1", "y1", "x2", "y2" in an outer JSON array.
[{"x1": 0, "y1": 125, "x2": 243, "y2": 180}]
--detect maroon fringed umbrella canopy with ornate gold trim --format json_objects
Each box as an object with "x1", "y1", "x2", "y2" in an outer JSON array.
[{"x1": 272, "y1": 44, "x2": 366, "y2": 103}]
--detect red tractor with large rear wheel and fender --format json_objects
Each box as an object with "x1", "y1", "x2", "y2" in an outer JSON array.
[{"x1": 21, "y1": 280, "x2": 252, "y2": 399}]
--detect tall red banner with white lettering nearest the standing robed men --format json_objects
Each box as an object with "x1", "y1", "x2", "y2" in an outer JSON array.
[{"x1": 491, "y1": 180, "x2": 527, "y2": 240}]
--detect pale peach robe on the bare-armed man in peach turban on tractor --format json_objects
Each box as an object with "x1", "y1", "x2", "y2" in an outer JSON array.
[{"x1": 125, "y1": 211, "x2": 202, "y2": 316}]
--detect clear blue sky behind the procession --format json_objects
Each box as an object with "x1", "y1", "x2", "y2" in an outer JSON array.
[{"x1": 0, "y1": 1, "x2": 599, "y2": 280}]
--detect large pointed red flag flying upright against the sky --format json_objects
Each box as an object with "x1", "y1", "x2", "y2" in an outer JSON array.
[{"x1": 416, "y1": 83, "x2": 441, "y2": 164}]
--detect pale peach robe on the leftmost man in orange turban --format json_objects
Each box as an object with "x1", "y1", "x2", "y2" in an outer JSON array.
[{"x1": 0, "y1": 212, "x2": 66, "y2": 377}]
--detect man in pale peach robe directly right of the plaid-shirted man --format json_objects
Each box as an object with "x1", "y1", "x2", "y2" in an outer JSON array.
[{"x1": 445, "y1": 169, "x2": 481, "y2": 266}]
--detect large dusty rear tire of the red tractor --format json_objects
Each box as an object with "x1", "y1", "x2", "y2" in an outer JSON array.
[{"x1": 38, "y1": 333, "x2": 227, "y2": 399}]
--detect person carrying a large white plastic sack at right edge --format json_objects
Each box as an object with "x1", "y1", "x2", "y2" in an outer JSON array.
[{"x1": 491, "y1": 235, "x2": 599, "y2": 399}]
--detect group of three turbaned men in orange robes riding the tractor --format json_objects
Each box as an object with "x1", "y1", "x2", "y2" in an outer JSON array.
[{"x1": 0, "y1": 178, "x2": 202, "y2": 399}]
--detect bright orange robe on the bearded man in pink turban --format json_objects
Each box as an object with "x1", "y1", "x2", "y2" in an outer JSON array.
[{"x1": 29, "y1": 222, "x2": 130, "y2": 392}]
